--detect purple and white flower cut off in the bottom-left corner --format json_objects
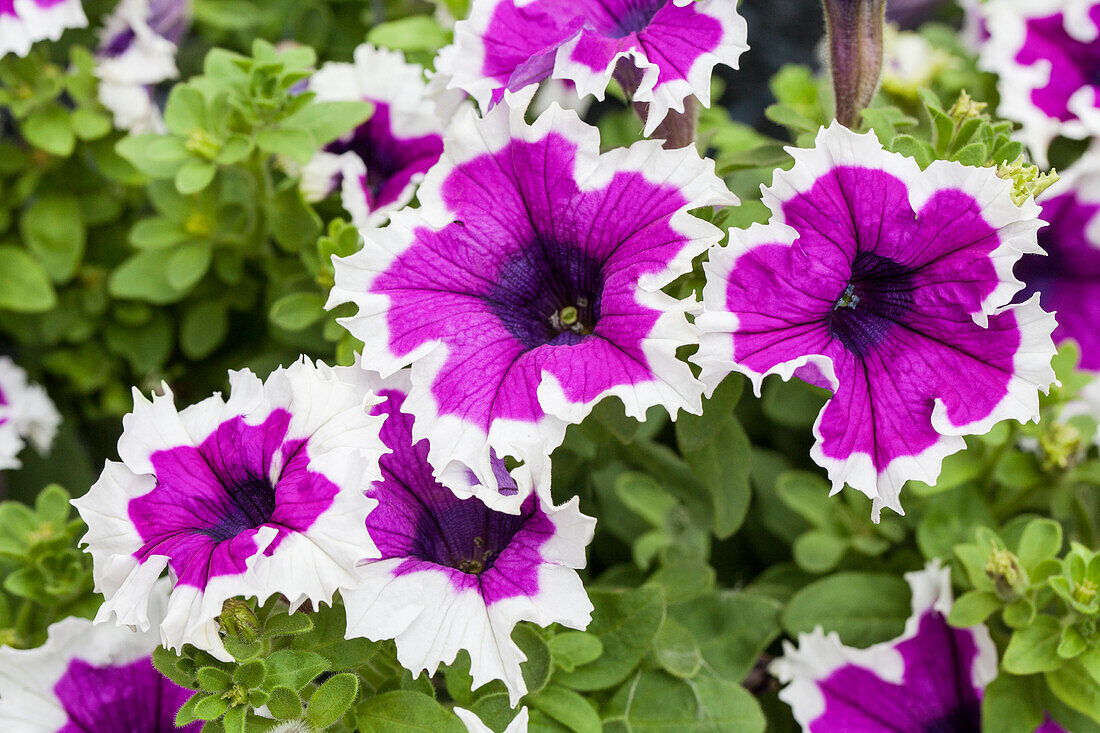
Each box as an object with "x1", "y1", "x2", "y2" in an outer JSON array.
[{"x1": 0, "y1": 582, "x2": 202, "y2": 733}]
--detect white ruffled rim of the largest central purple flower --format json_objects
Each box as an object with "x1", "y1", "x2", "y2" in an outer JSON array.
[{"x1": 326, "y1": 94, "x2": 738, "y2": 499}]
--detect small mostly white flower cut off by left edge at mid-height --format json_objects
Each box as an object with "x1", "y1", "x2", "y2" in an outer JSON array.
[{"x1": 0, "y1": 357, "x2": 62, "y2": 470}]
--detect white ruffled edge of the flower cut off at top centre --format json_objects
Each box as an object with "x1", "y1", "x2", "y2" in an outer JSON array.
[{"x1": 438, "y1": 0, "x2": 749, "y2": 136}]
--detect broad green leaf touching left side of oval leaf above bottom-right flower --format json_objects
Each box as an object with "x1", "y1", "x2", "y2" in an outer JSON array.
[{"x1": 669, "y1": 591, "x2": 783, "y2": 683}]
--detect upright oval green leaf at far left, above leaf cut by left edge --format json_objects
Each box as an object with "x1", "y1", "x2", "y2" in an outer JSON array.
[{"x1": 19, "y1": 194, "x2": 86, "y2": 283}]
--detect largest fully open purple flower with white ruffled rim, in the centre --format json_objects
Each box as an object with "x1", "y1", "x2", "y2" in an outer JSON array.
[{"x1": 329, "y1": 96, "x2": 736, "y2": 486}]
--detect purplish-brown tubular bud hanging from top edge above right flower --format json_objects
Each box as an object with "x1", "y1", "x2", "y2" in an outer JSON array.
[{"x1": 824, "y1": 0, "x2": 886, "y2": 128}]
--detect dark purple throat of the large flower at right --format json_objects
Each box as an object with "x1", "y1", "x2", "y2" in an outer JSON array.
[{"x1": 827, "y1": 251, "x2": 913, "y2": 354}]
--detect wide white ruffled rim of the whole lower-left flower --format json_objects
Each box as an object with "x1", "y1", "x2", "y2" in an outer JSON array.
[{"x1": 73, "y1": 358, "x2": 388, "y2": 661}]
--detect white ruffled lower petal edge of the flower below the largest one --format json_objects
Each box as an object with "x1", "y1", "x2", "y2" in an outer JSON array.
[{"x1": 341, "y1": 496, "x2": 595, "y2": 707}]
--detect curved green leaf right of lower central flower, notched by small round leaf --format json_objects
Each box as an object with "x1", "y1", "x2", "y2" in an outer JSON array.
[{"x1": 556, "y1": 588, "x2": 664, "y2": 691}]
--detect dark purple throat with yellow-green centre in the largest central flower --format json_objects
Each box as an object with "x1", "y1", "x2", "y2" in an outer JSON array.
[{"x1": 484, "y1": 241, "x2": 604, "y2": 349}]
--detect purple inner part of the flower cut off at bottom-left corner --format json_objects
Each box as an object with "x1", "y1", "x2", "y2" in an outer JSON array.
[{"x1": 54, "y1": 657, "x2": 202, "y2": 733}]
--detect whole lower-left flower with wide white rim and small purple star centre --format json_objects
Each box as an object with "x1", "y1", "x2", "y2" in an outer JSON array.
[{"x1": 73, "y1": 359, "x2": 384, "y2": 660}]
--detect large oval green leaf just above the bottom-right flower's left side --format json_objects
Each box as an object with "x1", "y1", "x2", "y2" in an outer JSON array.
[{"x1": 783, "y1": 572, "x2": 910, "y2": 648}]
